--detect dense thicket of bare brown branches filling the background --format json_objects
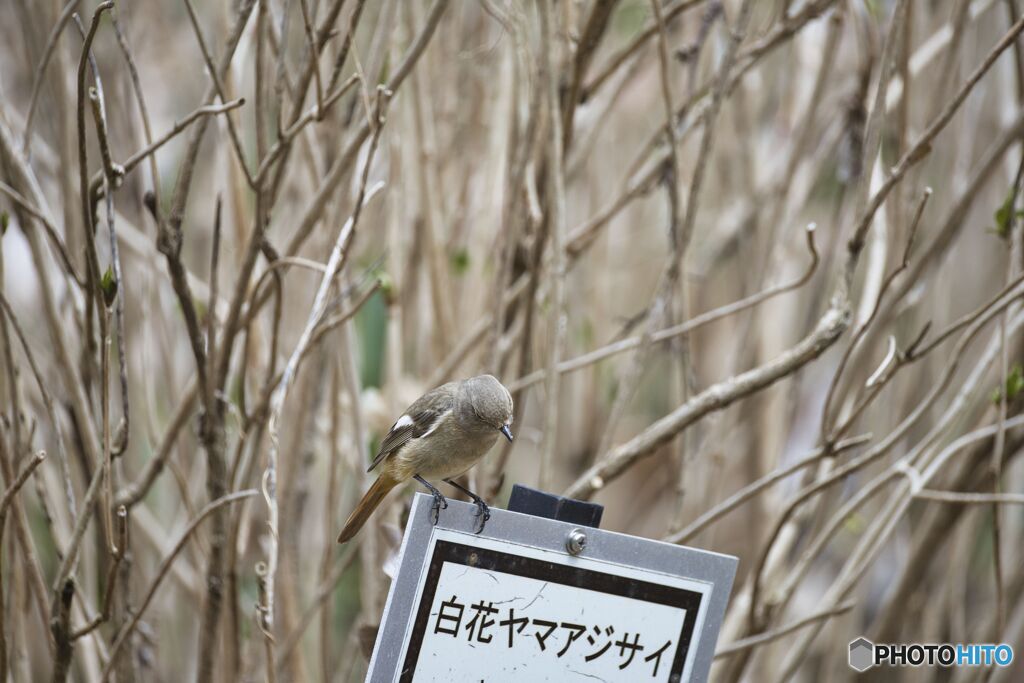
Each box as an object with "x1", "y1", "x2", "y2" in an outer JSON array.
[{"x1": 0, "y1": 0, "x2": 1024, "y2": 681}]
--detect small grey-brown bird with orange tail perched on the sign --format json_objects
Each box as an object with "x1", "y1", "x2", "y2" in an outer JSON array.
[{"x1": 338, "y1": 375, "x2": 512, "y2": 543}]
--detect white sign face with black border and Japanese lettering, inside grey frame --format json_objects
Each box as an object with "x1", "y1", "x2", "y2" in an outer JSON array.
[{"x1": 406, "y1": 530, "x2": 711, "y2": 683}]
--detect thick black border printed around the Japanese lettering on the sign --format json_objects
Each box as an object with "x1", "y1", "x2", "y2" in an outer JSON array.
[{"x1": 398, "y1": 540, "x2": 703, "y2": 683}]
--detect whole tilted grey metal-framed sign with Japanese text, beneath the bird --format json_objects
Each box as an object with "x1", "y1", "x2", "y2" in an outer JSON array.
[{"x1": 367, "y1": 494, "x2": 737, "y2": 683}]
